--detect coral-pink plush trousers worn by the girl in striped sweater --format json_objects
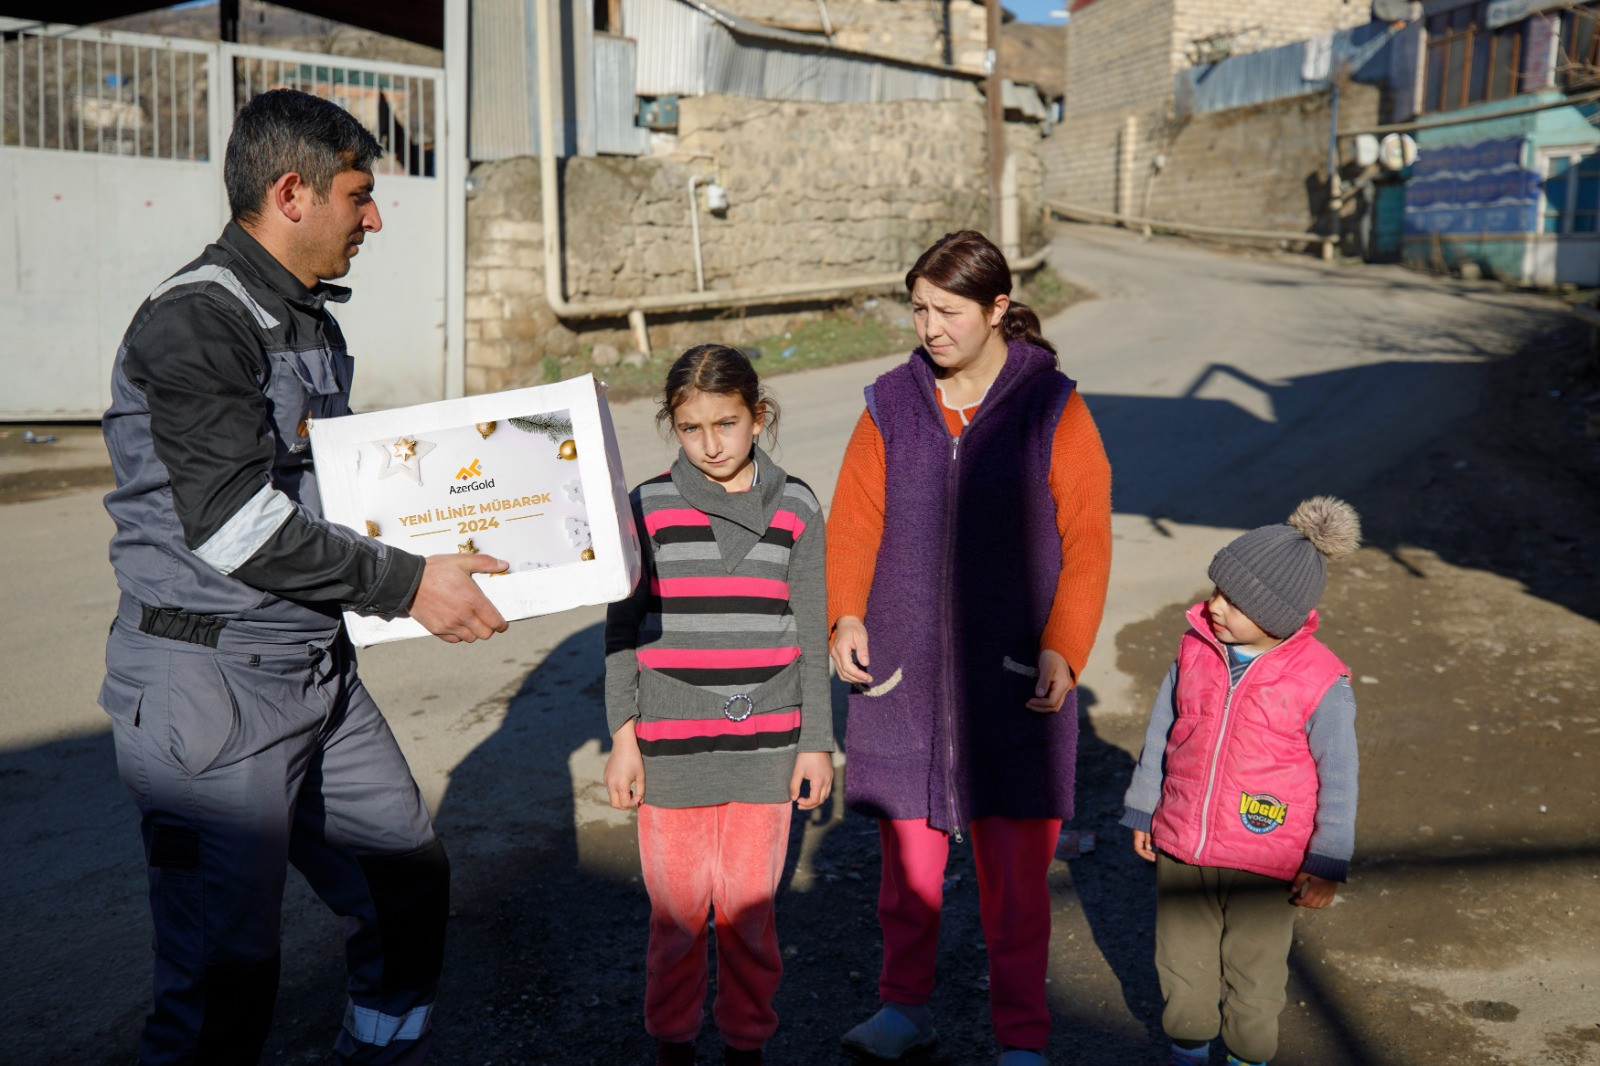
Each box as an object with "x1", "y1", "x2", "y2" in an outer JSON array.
[{"x1": 638, "y1": 804, "x2": 792, "y2": 1048}]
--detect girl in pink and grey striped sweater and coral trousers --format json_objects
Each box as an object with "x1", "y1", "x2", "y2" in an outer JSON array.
[{"x1": 605, "y1": 344, "x2": 834, "y2": 1064}]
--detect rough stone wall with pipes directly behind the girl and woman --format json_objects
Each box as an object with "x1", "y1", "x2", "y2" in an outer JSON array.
[{"x1": 467, "y1": 96, "x2": 1043, "y2": 392}]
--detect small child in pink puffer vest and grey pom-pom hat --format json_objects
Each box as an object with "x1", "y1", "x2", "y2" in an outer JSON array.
[{"x1": 1122, "y1": 496, "x2": 1360, "y2": 1066}]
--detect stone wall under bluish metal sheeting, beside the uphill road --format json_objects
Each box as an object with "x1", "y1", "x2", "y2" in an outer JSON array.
[{"x1": 1141, "y1": 85, "x2": 1382, "y2": 240}]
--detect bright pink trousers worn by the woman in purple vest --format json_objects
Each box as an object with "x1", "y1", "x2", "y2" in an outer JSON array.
[{"x1": 878, "y1": 818, "x2": 1061, "y2": 1048}]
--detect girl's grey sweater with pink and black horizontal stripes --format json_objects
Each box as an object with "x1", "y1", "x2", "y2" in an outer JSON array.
[{"x1": 605, "y1": 448, "x2": 834, "y2": 807}]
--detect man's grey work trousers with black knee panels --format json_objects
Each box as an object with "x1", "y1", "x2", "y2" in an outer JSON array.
[{"x1": 101, "y1": 605, "x2": 450, "y2": 1064}]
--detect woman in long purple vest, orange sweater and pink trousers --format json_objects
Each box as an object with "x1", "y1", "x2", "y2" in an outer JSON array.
[{"x1": 827, "y1": 230, "x2": 1110, "y2": 1066}]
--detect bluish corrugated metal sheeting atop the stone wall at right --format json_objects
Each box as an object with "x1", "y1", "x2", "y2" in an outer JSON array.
[{"x1": 1173, "y1": 22, "x2": 1394, "y2": 114}]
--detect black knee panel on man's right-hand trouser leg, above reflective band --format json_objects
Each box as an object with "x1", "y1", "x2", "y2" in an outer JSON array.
[{"x1": 360, "y1": 839, "x2": 450, "y2": 991}]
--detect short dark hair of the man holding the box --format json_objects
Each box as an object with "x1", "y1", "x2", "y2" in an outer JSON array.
[{"x1": 222, "y1": 90, "x2": 384, "y2": 222}]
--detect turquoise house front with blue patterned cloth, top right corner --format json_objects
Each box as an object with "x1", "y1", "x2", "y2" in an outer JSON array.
[{"x1": 1390, "y1": 0, "x2": 1600, "y2": 287}]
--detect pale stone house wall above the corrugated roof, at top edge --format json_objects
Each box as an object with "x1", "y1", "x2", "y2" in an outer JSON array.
[{"x1": 717, "y1": 0, "x2": 989, "y2": 70}]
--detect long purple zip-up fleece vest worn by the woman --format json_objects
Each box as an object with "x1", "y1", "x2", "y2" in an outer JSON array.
[{"x1": 845, "y1": 341, "x2": 1078, "y2": 832}]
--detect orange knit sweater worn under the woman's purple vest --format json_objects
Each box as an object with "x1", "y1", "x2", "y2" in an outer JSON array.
[{"x1": 827, "y1": 391, "x2": 1110, "y2": 683}]
